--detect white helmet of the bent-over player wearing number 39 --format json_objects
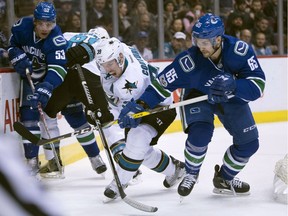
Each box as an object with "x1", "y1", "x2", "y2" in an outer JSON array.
[{"x1": 96, "y1": 37, "x2": 124, "y2": 67}]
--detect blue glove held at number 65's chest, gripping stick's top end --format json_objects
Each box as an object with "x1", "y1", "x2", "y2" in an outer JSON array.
[{"x1": 208, "y1": 73, "x2": 236, "y2": 104}]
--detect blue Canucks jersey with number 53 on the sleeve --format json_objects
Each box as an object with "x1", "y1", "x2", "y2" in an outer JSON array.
[{"x1": 9, "y1": 17, "x2": 67, "y2": 88}]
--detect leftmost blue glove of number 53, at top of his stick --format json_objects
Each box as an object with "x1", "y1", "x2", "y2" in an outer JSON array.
[{"x1": 8, "y1": 47, "x2": 33, "y2": 78}]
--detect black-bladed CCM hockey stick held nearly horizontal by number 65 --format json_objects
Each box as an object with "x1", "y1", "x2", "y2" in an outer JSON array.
[{"x1": 13, "y1": 95, "x2": 222, "y2": 145}]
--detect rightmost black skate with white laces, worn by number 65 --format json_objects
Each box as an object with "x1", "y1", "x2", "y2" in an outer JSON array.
[{"x1": 213, "y1": 165, "x2": 250, "y2": 196}]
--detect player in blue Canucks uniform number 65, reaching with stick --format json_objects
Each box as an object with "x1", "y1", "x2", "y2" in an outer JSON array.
[{"x1": 118, "y1": 13, "x2": 265, "y2": 196}]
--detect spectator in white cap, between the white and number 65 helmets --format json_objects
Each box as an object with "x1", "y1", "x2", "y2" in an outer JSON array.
[{"x1": 164, "y1": 32, "x2": 186, "y2": 59}]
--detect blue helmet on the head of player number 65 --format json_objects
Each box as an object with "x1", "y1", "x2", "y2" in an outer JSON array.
[{"x1": 192, "y1": 13, "x2": 225, "y2": 39}]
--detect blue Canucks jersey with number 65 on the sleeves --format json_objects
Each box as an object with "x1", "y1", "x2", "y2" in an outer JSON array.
[{"x1": 140, "y1": 35, "x2": 265, "y2": 108}]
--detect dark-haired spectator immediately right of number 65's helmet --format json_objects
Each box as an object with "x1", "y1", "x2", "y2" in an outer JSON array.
[{"x1": 225, "y1": 12, "x2": 243, "y2": 38}]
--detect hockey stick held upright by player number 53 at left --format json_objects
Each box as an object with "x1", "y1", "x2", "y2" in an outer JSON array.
[{"x1": 26, "y1": 68, "x2": 63, "y2": 176}]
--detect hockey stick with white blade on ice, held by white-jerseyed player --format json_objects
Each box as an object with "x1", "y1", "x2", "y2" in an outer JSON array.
[{"x1": 76, "y1": 64, "x2": 158, "y2": 212}]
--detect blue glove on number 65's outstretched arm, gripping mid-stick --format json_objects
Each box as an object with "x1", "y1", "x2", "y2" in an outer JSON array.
[{"x1": 118, "y1": 98, "x2": 144, "y2": 128}]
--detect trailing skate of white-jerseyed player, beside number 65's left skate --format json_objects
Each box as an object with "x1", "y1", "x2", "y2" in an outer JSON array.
[{"x1": 163, "y1": 156, "x2": 185, "y2": 188}]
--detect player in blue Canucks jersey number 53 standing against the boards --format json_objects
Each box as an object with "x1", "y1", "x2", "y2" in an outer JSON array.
[{"x1": 8, "y1": 2, "x2": 67, "y2": 175}]
